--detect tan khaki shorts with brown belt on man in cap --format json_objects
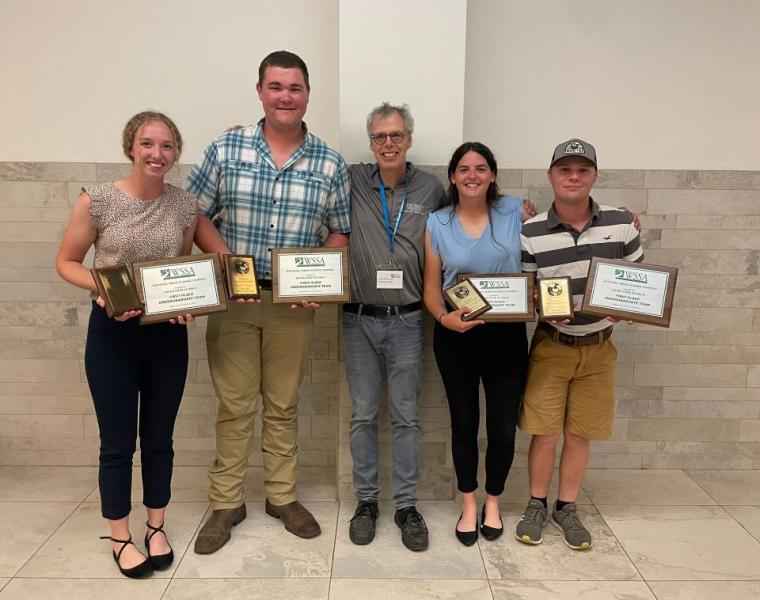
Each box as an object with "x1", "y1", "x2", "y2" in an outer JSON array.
[{"x1": 518, "y1": 329, "x2": 617, "y2": 440}]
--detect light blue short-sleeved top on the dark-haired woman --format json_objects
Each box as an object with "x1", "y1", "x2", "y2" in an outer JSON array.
[{"x1": 427, "y1": 196, "x2": 522, "y2": 288}]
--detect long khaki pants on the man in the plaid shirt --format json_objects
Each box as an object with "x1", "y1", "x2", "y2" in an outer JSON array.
[{"x1": 206, "y1": 290, "x2": 314, "y2": 510}]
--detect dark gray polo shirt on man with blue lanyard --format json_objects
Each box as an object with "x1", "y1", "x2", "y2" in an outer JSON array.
[{"x1": 349, "y1": 162, "x2": 446, "y2": 306}]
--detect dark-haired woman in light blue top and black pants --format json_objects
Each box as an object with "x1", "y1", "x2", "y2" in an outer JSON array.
[{"x1": 424, "y1": 142, "x2": 535, "y2": 546}]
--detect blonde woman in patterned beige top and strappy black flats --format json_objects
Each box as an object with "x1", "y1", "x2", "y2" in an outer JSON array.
[{"x1": 56, "y1": 112, "x2": 202, "y2": 577}]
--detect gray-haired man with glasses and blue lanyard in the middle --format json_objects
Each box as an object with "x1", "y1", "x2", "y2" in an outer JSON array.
[{"x1": 342, "y1": 102, "x2": 445, "y2": 551}]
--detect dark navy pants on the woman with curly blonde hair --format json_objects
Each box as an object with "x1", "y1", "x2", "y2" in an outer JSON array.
[{"x1": 84, "y1": 304, "x2": 187, "y2": 519}]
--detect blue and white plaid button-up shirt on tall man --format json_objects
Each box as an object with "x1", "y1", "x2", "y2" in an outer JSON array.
[{"x1": 187, "y1": 119, "x2": 351, "y2": 279}]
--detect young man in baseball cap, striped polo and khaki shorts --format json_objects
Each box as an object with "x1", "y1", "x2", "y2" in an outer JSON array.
[{"x1": 515, "y1": 138, "x2": 643, "y2": 550}]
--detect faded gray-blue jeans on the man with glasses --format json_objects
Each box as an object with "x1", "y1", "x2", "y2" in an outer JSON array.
[{"x1": 342, "y1": 310, "x2": 422, "y2": 509}]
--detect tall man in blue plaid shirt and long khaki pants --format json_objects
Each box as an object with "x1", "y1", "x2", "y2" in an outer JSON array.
[{"x1": 188, "y1": 51, "x2": 350, "y2": 554}]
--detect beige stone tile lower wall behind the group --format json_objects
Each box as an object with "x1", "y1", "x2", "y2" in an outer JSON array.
[{"x1": 0, "y1": 163, "x2": 760, "y2": 498}]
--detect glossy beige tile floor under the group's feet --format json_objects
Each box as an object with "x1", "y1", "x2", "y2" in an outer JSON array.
[{"x1": 0, "y1": 467, "x2": 760, "y2": 600}]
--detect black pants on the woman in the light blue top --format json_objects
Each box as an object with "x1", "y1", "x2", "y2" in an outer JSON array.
[{"x1": 433, "y1": 323, "x2": 528, "y2": 496}]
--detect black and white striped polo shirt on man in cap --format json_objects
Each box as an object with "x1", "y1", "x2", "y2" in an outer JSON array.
[{"x1": 520, "y1": 199, "x2": 644, "y2": 335}]
